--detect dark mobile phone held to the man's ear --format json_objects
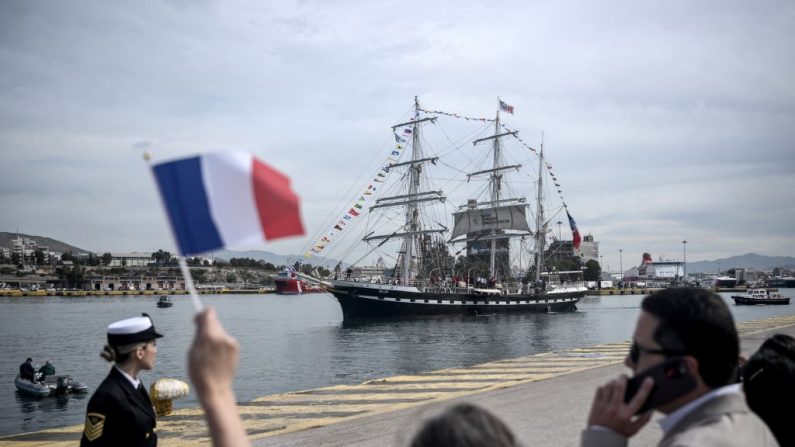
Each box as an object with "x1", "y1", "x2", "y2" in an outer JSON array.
[{"x1": 624, "y1": 357, "x2": 696, "y2": 414}]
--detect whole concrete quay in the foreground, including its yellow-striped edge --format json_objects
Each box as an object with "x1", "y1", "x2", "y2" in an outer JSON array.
[{"x1": 0, "y1": 315, "x2": 795, "y2": 447}]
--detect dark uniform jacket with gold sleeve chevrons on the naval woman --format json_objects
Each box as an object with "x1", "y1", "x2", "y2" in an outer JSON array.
[{"x1": 80, "y1": 367, "x2": 157, "y2": 447}]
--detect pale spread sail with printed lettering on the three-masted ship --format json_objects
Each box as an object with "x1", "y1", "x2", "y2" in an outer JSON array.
[{"x1": 450, "y1": 205, "x2": 530, "y2": 239}]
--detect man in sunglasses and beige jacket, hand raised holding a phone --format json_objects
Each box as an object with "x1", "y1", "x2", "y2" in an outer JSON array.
[{"x1": 581, "y1": 288, "x2": 778, "y2": 447}]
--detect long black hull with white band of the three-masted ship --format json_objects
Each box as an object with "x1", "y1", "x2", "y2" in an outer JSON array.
[{"x1": 328, "y1": 281, "x2": 585, "y2": 319}]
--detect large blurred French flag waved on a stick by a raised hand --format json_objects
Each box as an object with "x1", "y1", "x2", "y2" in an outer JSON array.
[{"x1": 152, "y1": 152, "x2": 304, "y2": 255}]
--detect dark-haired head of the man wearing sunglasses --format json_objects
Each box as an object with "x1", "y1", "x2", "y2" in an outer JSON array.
[{"x1": 626, "y1": 288, "x2": 740, "y2": 404}]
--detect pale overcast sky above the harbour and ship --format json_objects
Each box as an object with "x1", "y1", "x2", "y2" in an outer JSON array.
[{"x1": 0, "y1": 0, "x2": 795, "y2": 270}]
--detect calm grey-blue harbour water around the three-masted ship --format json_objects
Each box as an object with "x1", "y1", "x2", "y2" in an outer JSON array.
[{"x1": 0, "y1": 289, "x2": 795, "y2": 436}]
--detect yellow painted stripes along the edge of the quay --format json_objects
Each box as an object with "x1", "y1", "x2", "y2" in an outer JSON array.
[{"x1": 0, "y1": 315, "x2": 795, "y2": 447}]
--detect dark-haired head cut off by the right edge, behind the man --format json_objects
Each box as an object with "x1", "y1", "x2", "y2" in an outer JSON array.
[{"x1": 743, "y1": 334, "x2": 795, "y2": 445}]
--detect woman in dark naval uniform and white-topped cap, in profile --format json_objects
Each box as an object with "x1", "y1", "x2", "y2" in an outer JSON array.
[{"x1": 80, "y1": 314, "x2": 162, "y2": 447}]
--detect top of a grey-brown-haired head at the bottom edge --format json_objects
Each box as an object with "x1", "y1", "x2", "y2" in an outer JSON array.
[{"x1": 410, "y1": 404, "x2": 519, "y2": 447}]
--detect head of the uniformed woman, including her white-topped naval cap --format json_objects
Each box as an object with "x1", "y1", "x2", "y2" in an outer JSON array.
[{"x1": 100, "y1": 314, "x2": 162, "y2": 370}]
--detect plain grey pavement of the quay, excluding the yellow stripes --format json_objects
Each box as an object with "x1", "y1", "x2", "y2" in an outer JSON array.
[{"x1": 254, "y1": 315, "x2": 795, "y2": 447}]
